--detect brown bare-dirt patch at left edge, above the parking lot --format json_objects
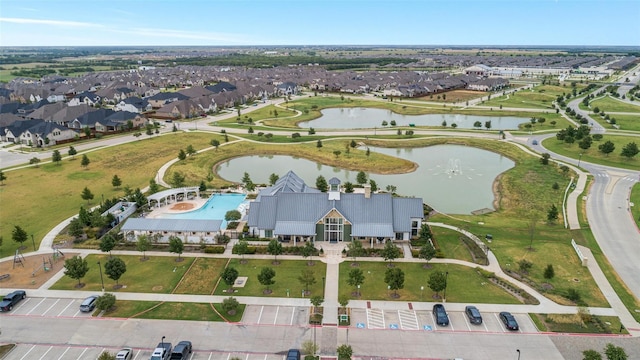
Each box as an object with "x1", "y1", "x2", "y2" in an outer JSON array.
[{"x1": 0, "y1": 252, "x2": 77, "y2": 289}]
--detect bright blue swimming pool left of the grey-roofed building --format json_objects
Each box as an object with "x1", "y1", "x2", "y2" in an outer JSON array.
[{"x1": 158, "y1": 194, "x2": 248, "y2": 229}]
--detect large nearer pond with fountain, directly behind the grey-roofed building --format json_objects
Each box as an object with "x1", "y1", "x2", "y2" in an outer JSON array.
[{"x1": 217, "y1": 145, "x2": 515, "y2": 214}]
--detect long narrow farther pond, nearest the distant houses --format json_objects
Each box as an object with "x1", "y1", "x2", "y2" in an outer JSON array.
[{"x1": 298, "y1": 108, "x2": 529, "y2": 130}]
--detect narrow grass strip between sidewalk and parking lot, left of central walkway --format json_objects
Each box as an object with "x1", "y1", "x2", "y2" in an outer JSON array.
[{"x1": 103, "y1": 300, "x2": 246, "y2": 322}]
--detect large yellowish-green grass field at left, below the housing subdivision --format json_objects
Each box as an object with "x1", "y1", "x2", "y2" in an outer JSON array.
[{"x1": 0, "y1": 133, "x2": 222, "y2": 257}]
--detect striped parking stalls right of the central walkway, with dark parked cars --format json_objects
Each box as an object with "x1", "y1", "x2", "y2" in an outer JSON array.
[{"x1": 351, "y1": 309, "x2": 538, "y2": 333}]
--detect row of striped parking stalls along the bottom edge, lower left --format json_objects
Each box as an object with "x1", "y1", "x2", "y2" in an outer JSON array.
[{"x1": 3, "y1": 344, "x2": 300, "y2": 360}]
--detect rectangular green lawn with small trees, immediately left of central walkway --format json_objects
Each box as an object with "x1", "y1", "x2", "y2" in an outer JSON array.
[{"x1": 214, "y1": 259, "x2": 327, "y2": 297}]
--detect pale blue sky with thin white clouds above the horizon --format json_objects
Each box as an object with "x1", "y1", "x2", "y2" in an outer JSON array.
[{"x1": 0, "y1": 0, "x2": 640, "y2": 46}]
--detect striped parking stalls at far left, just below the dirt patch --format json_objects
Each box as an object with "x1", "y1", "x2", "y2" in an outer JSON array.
[{"x1": 3, "y1": 293, "x2": 97, "y2": 317}]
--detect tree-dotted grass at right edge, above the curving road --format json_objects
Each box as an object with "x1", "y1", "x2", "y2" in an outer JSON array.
[{"x1": 543, "y1": 134, "x2": 640, "y2": 170}]
